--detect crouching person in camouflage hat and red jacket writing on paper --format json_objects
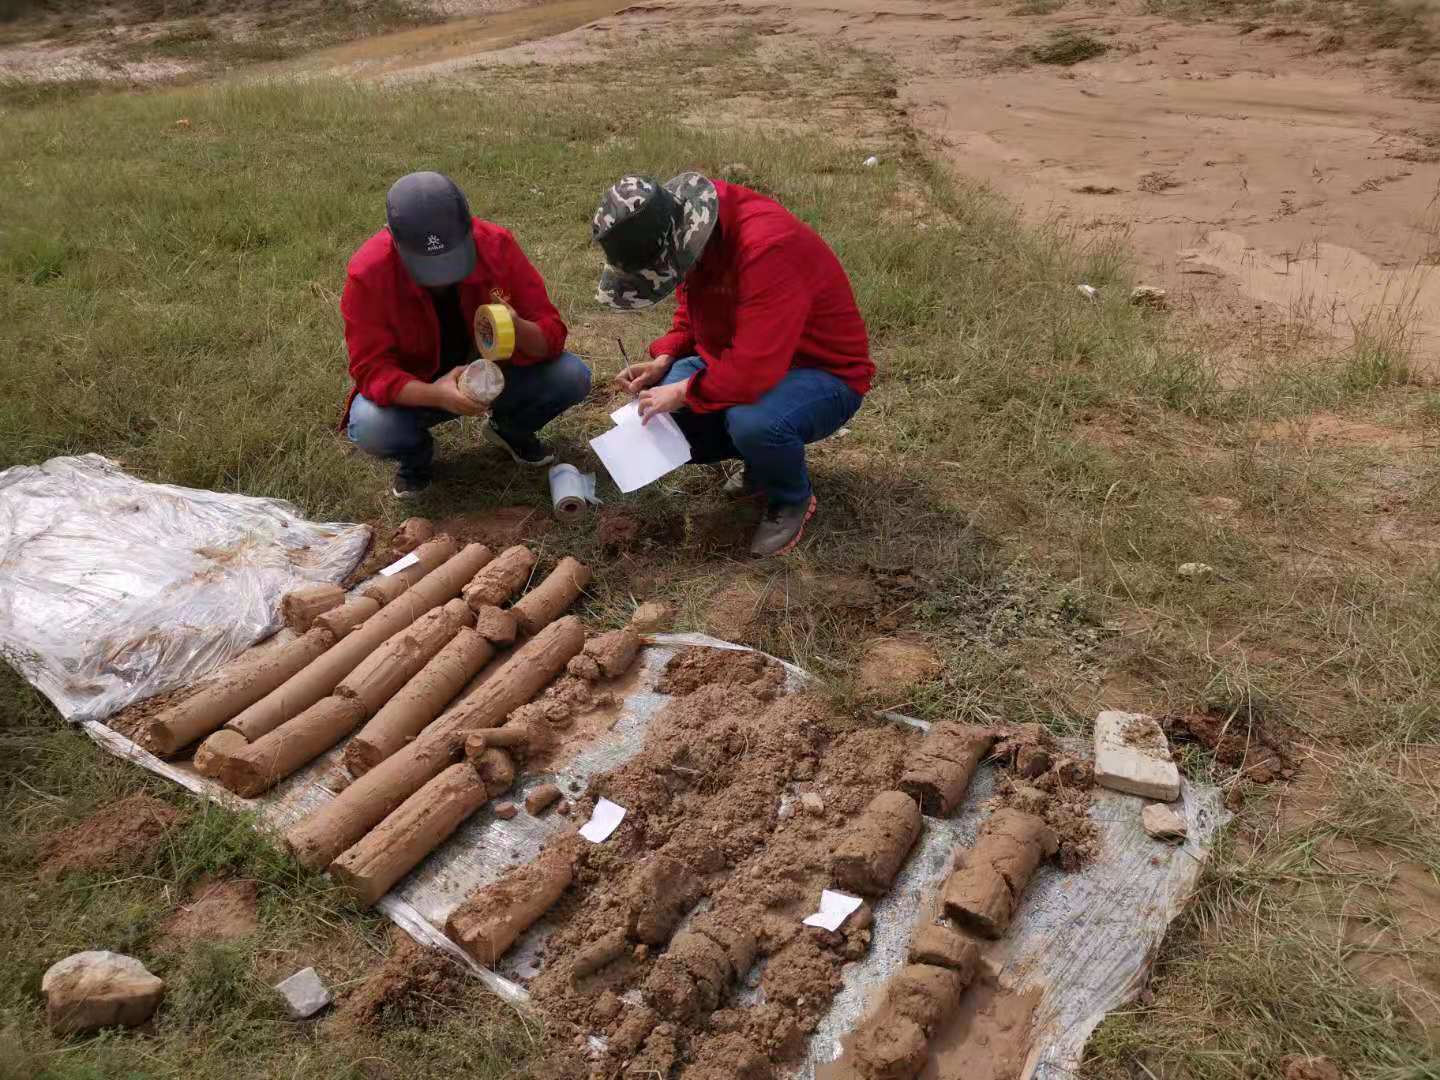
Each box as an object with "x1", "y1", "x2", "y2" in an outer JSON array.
[{"x1": 590, "y1": 173, "x2": 876, "y2": 556}]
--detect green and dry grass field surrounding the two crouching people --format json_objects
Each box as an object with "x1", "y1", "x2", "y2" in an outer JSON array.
[{"x1": 0, "y1": 23, "x2": 1440, "y2": 1080}]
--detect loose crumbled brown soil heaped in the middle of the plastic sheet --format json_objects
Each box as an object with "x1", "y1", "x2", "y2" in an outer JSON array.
[{"x1": 530, "y1": 679, "x2": 917, "y2": 1077}]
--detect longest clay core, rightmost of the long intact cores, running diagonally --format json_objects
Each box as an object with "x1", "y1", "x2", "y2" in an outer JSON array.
[{"x1": 285, "y1": 618, "x2": 585, "y2": 868}]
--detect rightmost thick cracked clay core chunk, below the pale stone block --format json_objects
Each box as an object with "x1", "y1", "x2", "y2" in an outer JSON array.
[{"x1": 942, "y1": 808, "x2": 1060, "y2": 937}]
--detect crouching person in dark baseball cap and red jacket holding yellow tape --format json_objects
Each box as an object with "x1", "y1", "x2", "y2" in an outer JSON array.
[{"x1": 340, "y1": 173, "x2": 590, "y2": 498}]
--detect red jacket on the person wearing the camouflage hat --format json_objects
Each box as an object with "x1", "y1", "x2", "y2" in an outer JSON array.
[{"x1": 649, "y1": 180, "x2": 876, "y2": 412}]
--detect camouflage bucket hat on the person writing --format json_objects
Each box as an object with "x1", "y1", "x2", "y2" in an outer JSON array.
[{"x1": 590, "y1": 173, "x2": 720, "y2": 311}]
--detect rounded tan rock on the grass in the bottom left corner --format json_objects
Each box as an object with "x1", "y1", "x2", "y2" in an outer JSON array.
[{"x1": 40, "y1": 950, "x2": 166, "y2": 1035}]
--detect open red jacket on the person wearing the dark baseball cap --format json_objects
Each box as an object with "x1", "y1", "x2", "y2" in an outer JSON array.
[{"x1": 340, "y1": 217, "x2": 566, "y2": 415}]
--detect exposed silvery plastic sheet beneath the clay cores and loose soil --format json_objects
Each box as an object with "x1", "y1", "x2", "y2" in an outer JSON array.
[{"x1": 75, "y1": 634, "x2": 1227, "y2": 1080}]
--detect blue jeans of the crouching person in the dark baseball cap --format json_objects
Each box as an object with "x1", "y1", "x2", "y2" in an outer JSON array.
[{"x1": 346, "y1": 353, "x2": 590, "y2": 477}]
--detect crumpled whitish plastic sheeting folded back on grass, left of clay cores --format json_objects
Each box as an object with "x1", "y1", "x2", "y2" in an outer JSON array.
[{"x1": 0, "y1": 454, "x2": 370, "y2": 721}]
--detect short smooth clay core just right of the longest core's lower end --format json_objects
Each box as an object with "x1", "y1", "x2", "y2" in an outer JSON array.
[{"x1": 330, "y1": 762, "x2": 488, "y2": 907}]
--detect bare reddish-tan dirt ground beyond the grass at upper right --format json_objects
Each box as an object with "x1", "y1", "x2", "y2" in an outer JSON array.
[{"x1": 377, "y1": 0, "x2": 1440, "y2": 372}]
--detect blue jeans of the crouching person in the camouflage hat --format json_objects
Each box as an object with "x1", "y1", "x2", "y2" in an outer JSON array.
[{"x1": 661, "y1": 356, "x2": 864, "y2": 505}]
